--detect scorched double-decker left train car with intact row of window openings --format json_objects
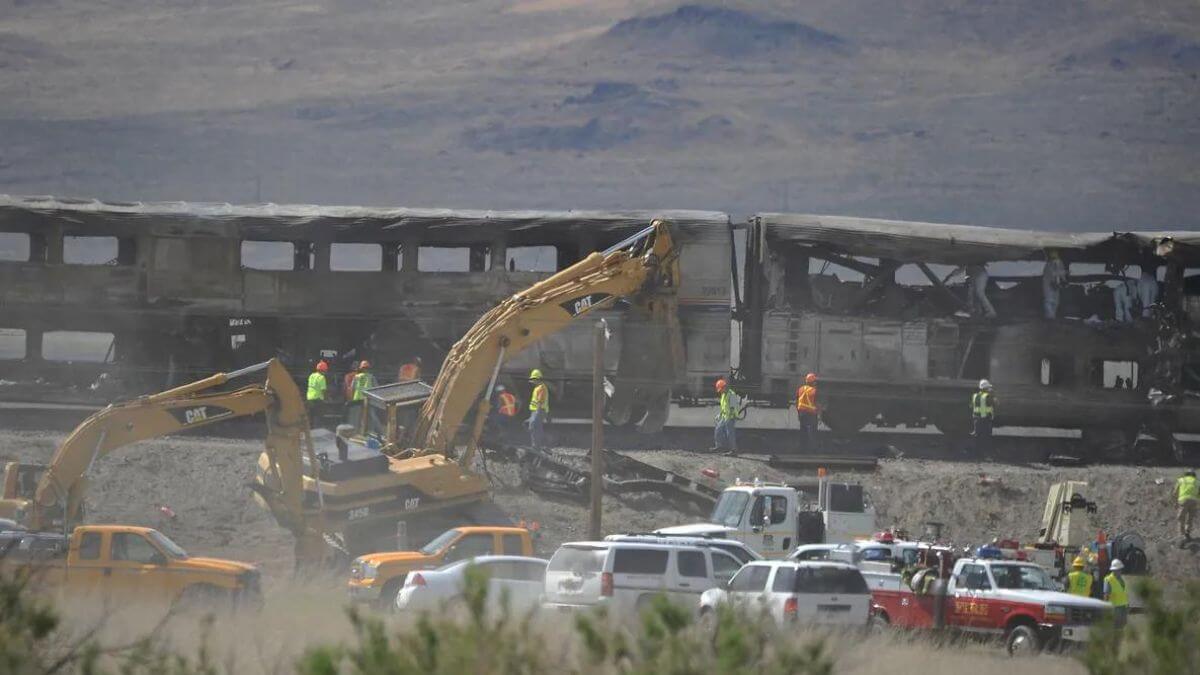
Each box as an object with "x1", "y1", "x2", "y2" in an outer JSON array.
[{"x1": 0, "y1": 197, "x2": 731, "y2": 426}]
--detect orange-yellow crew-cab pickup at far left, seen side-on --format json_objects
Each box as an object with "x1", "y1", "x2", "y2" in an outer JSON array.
[{"x1": 0, "y1": 525, "x2": 262, "y2": 607}]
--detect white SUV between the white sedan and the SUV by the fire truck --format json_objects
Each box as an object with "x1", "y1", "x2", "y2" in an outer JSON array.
[{"x1": 542, "y1": 542, "x2": 742, "y2": 615}]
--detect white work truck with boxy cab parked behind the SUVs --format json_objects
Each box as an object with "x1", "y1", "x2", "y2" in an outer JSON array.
[{"x1": 656, "y1": 476, "x2": 875, "y2": 558}]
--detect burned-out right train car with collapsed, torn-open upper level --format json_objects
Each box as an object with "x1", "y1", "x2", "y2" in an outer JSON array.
[{"x1": 734, "y1": 214, "x2": 1200, "y2": 456}]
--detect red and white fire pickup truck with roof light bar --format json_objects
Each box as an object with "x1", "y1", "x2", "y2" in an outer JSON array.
[{"x1": 868, "y1": 558, "x2": 1112, "y2": 653}]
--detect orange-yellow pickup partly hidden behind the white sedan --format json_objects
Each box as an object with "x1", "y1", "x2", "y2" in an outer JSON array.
[{"x1": 347, "y1": 526, "x2": 533, "y2": 608}]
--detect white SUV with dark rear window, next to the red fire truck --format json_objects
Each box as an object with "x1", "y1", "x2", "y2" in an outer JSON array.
[{"x1": 700, "y1": 560, "x2": 871, "y2": 626}]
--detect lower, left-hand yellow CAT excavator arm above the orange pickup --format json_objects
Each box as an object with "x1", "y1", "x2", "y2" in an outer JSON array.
[{"x1": 29, "y1": 359, "x2": 320, "y2": 542}]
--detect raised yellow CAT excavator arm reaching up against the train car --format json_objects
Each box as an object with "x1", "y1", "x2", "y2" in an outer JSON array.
[{"x1": 406, "y1": 220, "x2": 683, "y2": 465}]
